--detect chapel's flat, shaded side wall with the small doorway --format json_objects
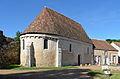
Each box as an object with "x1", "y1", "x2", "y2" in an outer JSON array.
[{"x1": 58, "y1": 37, "x2": 93, "y2": 65}]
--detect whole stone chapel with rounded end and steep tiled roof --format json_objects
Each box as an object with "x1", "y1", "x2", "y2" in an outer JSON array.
[{"x1": 20, "y1": 7, "x2": 93, "y2": 67}]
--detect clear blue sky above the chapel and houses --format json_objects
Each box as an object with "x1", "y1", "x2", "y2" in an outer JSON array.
[{"x1": 0, "y1": 0, "x2": 120, "y2": 40}]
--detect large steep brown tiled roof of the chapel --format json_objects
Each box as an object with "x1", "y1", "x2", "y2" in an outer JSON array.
[{"x1": 21, "y1": 7, "x2": 92, "y2": 43}]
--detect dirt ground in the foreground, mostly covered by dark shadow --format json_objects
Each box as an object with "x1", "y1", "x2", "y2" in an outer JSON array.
[{"x1": 0, "y1": 66, "x2": 100, "y2": 79}]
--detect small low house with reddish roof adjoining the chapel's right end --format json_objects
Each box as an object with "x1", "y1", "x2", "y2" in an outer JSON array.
[{"x1": 92, "y1": 39, "x2": 118, "y2": 65}]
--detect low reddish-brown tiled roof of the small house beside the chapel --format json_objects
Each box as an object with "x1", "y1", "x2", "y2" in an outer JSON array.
[{"x1": 92, "y1": 39, "x2": 117, "y2": 51}]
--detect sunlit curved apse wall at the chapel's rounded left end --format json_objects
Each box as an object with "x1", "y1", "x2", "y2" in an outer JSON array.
[{"x1": 20, "y1": 34, "x2": 57, "y2": 67}]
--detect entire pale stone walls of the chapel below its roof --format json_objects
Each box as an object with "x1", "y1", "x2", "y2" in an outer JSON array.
[{"x1": 20, "y1": 34, "x2": 93, "y2": 67}]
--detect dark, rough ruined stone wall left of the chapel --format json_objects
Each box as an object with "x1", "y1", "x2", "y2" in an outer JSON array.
[{"x1": 0, "y1": 31, "x2": 19, "y2": 66}]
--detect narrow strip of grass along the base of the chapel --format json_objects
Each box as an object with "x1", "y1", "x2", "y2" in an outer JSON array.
[{"x1": 0, "y1": 65, "x2": 77, "y2": 70}]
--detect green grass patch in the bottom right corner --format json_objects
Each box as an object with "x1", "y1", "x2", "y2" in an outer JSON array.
[{"x1": 88, "y1": 70, "x2": 120, "y2": 79}]
